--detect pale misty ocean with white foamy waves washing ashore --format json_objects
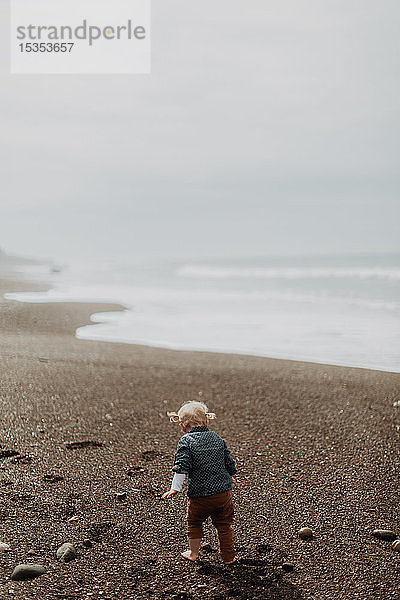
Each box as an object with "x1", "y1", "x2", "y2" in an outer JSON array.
[{"x1": 6, "y1": 255, "x2": 400, "y2": 372}]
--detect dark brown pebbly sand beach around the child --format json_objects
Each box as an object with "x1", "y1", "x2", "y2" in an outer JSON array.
[{"x1": 0, "y1": 281, "x2": 400, "y2": 600}]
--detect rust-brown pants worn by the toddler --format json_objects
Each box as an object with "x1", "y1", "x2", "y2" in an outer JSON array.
[{"x1": 187, "y1": 490, "x2": 235, "y2": 562}]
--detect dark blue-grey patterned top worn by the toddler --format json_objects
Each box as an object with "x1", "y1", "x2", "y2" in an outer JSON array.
[{"x1": 172, "y1": 425, "x2": 237, "y2": 498}]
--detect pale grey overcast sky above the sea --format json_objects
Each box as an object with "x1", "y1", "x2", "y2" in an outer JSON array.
[{"x1": 0, "y1": 0, "x2": 400, "y2": 257}]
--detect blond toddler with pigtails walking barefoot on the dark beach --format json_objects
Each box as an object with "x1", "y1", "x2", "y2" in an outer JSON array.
[{"x1": 162, "y1": 402, "x2": 237, "y2": 564}]
